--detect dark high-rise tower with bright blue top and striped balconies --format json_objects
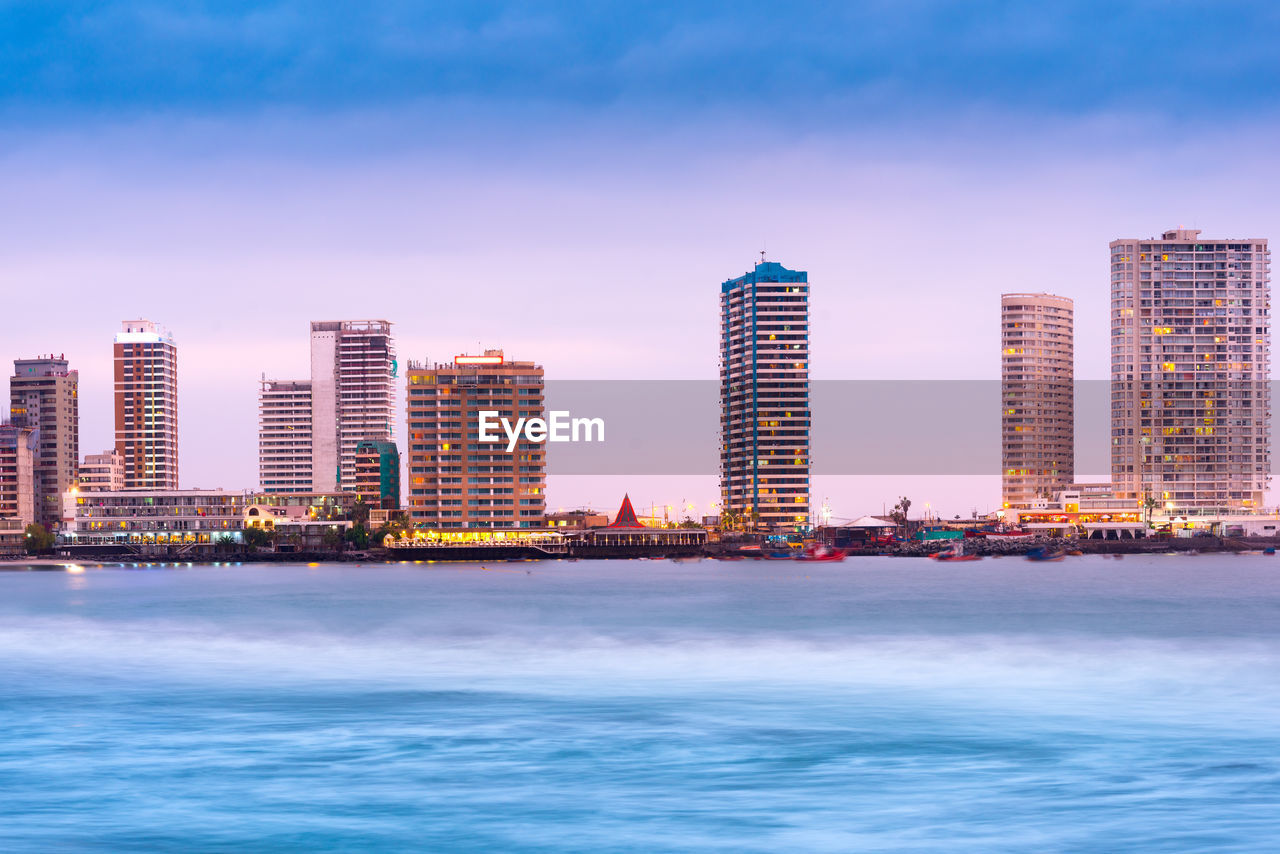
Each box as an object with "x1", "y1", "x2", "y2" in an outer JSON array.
[{"x1": 721, "y1": 261, "x2": 809, "y2": 529}]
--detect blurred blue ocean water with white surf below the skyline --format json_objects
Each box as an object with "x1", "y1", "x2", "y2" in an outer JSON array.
[{"x1": 0, "y1": 554, "x2": 1280, "y2": 853}]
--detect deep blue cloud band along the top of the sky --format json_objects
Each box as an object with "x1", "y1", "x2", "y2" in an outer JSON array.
[{"x1": 0, "y1": 0, "x2": 1280, "y2": 126}]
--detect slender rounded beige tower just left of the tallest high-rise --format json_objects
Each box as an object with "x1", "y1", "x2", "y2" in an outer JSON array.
[{"x1": 1000, "y1": 293, "x2": 1075, "y2": 508}]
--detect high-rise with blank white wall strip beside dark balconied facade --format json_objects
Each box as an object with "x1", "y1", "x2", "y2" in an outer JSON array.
[{"x1": 311, "y1": 320, "x2": 398, "y2": 492}]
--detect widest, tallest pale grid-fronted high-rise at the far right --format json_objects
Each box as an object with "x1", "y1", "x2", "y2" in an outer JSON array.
[{"x1": 1111, "y1": 228, "x2": 1271, "y2": 515}]
